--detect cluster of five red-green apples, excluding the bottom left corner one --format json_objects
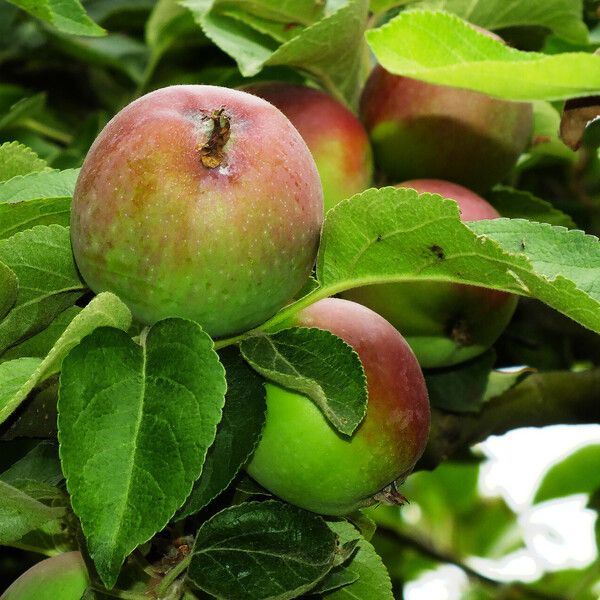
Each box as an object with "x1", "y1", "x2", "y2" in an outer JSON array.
[{"x1": 71, "y1": 59, "x2": 532, "y2": 515}]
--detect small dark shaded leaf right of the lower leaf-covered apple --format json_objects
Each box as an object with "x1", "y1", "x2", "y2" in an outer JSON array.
[{"x1": 425, "y1": 351, "x2": 496, "y2": 413}]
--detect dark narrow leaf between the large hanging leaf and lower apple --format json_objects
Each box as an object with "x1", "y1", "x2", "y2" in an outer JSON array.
[{"x1": 177, "y1": 348, "x2": 266, "y2": 519}]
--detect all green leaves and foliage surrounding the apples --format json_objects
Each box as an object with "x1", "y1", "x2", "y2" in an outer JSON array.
[{"x1": 0, "y1": 0, "x2": 600, "y2": 600}]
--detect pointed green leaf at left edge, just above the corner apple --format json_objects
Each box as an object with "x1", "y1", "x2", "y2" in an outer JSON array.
[{"x1": 0, "y1": 481, "x2": 65, "y2": 545}]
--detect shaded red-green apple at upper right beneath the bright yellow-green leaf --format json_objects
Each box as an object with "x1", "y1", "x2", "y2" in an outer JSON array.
[{"x1": 360, "y1": 65, "x2": 533, "y2": 190}]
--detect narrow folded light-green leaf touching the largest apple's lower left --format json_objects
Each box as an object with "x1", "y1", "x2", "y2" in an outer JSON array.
[{"x1": 0, "y1": 292, "x2": 131, "y2": 423}]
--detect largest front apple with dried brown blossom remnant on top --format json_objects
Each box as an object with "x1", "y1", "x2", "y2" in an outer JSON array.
[{"x1": 71, "y1": 85, "x2": 323, "y2": 336}]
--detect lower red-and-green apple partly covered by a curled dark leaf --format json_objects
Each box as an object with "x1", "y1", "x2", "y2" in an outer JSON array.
[{"x1": 247, "y1": 298, "x2": 430, "y2": 515}]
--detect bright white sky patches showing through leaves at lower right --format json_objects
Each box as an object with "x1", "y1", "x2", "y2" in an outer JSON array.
[{"x1": 404, "y1": 425, "x2": 600, "y2": 600}]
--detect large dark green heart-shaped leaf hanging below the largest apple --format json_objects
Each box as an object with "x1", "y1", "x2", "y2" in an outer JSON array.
[{"x1": 58, "y1": 319, "x2": 226, "y2": 587}]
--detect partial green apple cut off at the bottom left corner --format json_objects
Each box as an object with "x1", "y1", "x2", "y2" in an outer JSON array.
[{"x1": 0, "y1": 552, "x2": 90, "y2": 600}]
